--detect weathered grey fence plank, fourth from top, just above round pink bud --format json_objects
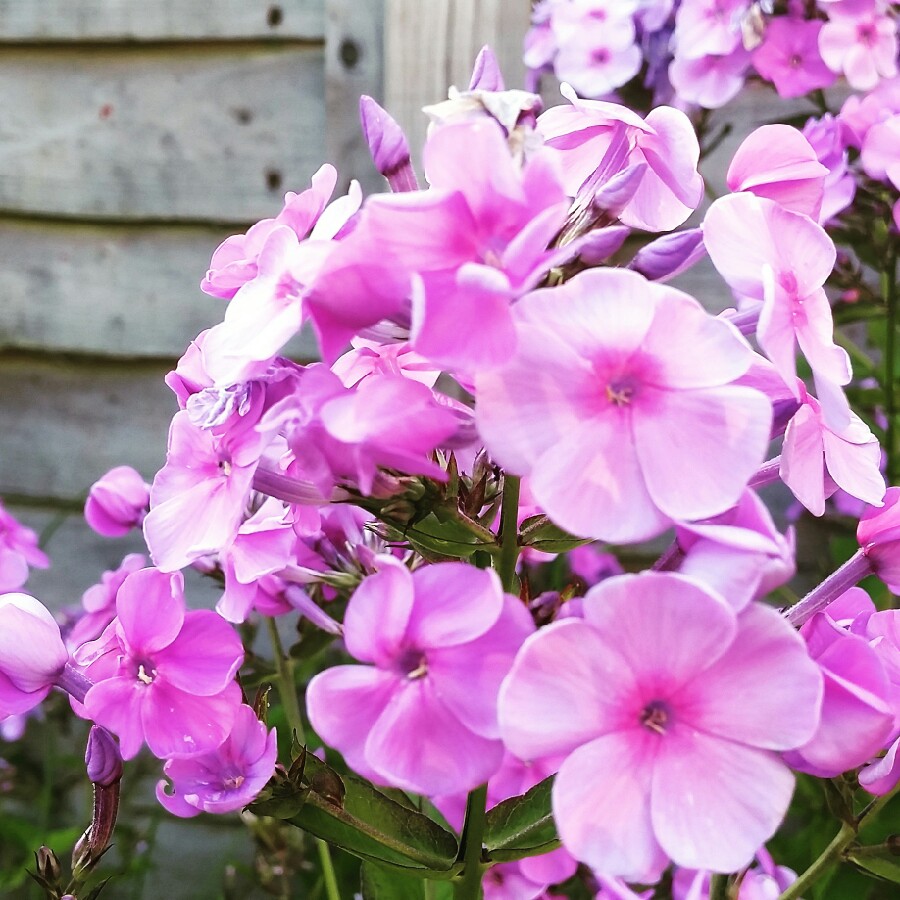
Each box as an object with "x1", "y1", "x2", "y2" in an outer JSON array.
[{"x1": 0, "y1": 358, "x2": 178, "y2": 501}]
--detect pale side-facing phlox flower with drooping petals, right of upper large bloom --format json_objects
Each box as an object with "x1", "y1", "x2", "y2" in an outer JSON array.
[{"x1": 703, "y1": 192, "x2": 851, "y2": 404}]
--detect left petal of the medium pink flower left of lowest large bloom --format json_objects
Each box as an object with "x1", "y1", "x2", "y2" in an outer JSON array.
[{"x1": 306, "y1": 666, "x2": 399, "y2": 777}]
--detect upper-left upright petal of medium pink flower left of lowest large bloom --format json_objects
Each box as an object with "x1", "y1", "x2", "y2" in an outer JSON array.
[{"x1": 344, "y1": 556, "x2": 414, "y2": 666}]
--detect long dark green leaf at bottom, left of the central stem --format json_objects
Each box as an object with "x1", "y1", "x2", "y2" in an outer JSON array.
[{"x1": 289, "y1": 754, "x2": 459, "y2": 877}]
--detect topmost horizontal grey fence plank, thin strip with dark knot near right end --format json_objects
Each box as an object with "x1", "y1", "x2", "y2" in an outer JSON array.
[{"x1": 0, "y1": 0, "x2": 324, "y2": 42}]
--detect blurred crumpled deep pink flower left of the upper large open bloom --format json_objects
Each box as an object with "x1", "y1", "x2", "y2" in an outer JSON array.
[{"x1": 260, "y1": 365, "x2": 462, "y2": 497}]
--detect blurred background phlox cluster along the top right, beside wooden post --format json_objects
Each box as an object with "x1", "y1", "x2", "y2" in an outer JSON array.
[{"x1": 525, "y1": 0, "x2": 898, "y2": 109}]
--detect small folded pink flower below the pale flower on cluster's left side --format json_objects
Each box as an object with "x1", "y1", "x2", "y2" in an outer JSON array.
[{"x1": 216, "y1": 497, "x2": 297, "y2": 622}]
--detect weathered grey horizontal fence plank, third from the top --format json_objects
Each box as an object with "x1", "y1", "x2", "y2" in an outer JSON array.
[{"x1": 0, "y1": 219, "x2": 317, "y2": 359}]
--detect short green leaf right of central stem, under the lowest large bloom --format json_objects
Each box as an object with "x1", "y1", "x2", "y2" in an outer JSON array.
[{"x1": 484, "y1": 775, "x2": 559, "y2": 862}]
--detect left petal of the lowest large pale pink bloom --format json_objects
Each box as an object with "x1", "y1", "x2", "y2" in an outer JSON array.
[{"x1": 497, "y1": 619, "x2": 639, "y2": 760}]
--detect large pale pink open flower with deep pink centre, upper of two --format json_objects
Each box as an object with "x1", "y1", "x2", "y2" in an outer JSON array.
[{"x1": 476, "y1": 269, "x2": 771, "y2": 542}]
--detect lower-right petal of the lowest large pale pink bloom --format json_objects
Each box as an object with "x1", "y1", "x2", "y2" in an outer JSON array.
[{"x1": 652, "y1": 726, "x2": 794, "y2": 872}]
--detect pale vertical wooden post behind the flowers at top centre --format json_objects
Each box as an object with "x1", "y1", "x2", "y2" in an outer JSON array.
[{"x1": 384, "y1": 0, "x2": 530, "y2": 158}]
